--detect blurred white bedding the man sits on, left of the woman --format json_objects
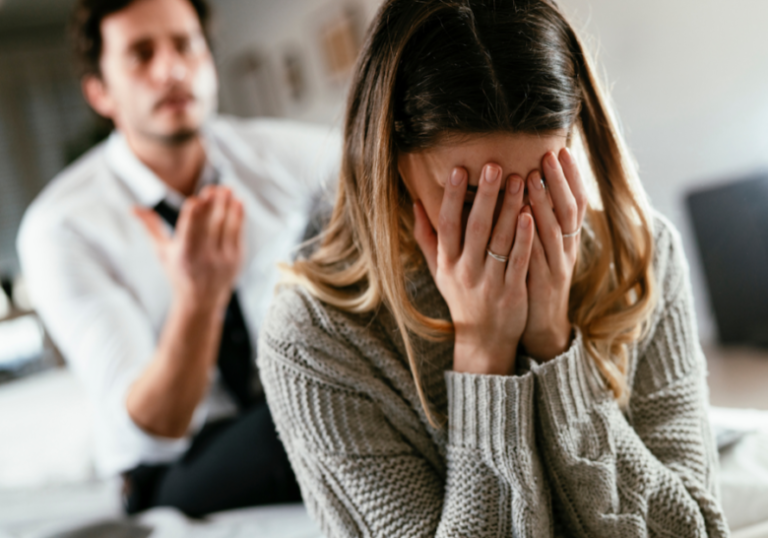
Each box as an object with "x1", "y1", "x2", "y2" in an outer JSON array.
[{"x1": 0, "y1": 368, "x2": 321, "y2": 538}]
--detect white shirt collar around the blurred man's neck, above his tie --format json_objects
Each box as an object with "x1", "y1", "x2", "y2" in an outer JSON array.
[{"x1": 106, "y1": 130, "x2": 219, "y2": 210}]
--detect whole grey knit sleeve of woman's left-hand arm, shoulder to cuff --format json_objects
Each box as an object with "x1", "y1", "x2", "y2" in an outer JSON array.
[{"x1": 259, "y1": 289, "x2": 552, "y2": 538}]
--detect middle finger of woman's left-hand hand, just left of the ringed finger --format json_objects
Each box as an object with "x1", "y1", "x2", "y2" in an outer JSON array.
[{"x1": 462, "y1": 164, "x2": 502, "y2": 268}]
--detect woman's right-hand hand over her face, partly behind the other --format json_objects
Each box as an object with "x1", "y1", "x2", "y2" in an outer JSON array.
[{"x1": 521, "y1": 148, "x2": 587, "y2": 361}]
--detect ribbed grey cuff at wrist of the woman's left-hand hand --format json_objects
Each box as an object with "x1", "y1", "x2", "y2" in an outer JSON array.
[{"x1": 445, "y1": 371, "x2": 534, "y2": 459}]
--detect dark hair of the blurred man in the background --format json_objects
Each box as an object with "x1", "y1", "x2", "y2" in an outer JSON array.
[{"x1": 71, "y1": 0, "x2": 210, "y2": 76}]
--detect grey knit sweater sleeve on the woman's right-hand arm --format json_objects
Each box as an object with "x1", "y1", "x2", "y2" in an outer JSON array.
[{"x1": 533, "y1": 215, "x2": 729, "y2": 538}]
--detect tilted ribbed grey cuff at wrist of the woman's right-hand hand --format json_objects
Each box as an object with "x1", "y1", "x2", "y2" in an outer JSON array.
[{"x1": 531, "y1": 329, "x2": 612, "y2": 428}]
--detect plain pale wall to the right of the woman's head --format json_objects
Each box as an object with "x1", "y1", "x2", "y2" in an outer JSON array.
[{"x1": 560, "y1": 0, "x2": 768, "y2": 340}]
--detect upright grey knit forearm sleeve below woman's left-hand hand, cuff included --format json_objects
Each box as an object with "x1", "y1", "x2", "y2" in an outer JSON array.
[{"x1": 438, "y1": 372, "x2": 552, "y2": 537}]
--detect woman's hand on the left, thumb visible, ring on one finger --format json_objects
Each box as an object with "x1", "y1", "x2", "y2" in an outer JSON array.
[{"x1": 414, "y1": 164, "x2": 533, "y2": 375}]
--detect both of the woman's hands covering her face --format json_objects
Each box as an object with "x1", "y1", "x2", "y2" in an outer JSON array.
[{"x1": 414, "y1": 149, "x2": 587, "y2": 375}]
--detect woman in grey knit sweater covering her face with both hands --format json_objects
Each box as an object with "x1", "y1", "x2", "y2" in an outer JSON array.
[{"x1": 259, "y1": 0, "x2": 728, "y2": 537}]
